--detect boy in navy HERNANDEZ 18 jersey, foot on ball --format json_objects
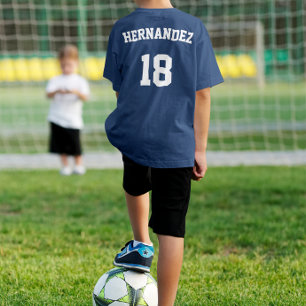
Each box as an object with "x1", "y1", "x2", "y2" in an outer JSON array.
[{"x1": 103, "y1": 0, "x2": 223, "y2": 306}]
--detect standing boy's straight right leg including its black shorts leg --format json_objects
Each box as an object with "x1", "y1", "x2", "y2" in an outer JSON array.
[{"x1": 149, "y1": 167, "x2": 193, "y2": 306}]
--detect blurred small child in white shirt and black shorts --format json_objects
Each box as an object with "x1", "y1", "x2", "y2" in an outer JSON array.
[{"x1": 46, "y1": 45, "x2": 90, "y2": 175}]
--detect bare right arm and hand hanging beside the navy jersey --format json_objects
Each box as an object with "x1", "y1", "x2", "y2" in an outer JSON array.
[{"x1": 193, "y1": 88, "x2": 210, "y2": 181}]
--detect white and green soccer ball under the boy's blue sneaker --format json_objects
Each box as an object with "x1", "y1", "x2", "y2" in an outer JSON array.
[{"x1": 92, "y1": 268, "x2": 158, "y2": 306}]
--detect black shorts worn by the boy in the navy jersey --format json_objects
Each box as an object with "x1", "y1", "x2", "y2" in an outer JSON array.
[{"x1": 122, "y1": 154, "x2": 193, "y2": 237}]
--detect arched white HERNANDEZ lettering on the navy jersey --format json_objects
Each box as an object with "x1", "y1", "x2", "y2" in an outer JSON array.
[{"x1": 122, "y1": 28, "x2": 194, "y2": 44}]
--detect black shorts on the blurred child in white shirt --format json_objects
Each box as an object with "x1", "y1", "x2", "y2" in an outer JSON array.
[{"x1": 49, "y1": 122, "x2": 82, "y2": 156}]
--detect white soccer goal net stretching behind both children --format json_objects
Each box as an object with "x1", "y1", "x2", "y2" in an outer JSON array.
[{"x1": 0, "y1": 0, "x2": 306, "y2": 157}]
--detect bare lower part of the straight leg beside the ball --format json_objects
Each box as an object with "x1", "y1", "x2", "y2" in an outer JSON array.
[{"x1": 157, "y1": 235, "x2": 184, "y2": 306}]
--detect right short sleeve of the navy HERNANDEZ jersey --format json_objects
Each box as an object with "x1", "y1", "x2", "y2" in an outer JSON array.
[{"x1": 196, "y1": 22, "x2": 224, "y2": 90}]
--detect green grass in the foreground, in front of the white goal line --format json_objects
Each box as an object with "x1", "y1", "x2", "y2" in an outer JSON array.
[{"x1": 0, "y1": 167, "x2": 306, "y2": 306}]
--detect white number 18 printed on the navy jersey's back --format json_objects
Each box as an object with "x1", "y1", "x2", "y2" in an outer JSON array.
[{"x1": 140, "y1": 54, "x2": 172, "y2": 87}]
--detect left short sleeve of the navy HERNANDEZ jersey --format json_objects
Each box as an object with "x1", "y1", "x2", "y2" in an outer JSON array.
[{"x1": 103, "y1": 29, "x2": 122, "y2": 92}]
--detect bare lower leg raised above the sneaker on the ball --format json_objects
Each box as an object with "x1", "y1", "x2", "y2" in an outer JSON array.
[{"x1": 125, "y1": 191, "x2": 151, "y2": 244}]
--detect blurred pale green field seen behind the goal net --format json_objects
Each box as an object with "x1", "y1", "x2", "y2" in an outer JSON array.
[{"x1": 0, "y1": 81, "x2": 306, "y2": 153}]
